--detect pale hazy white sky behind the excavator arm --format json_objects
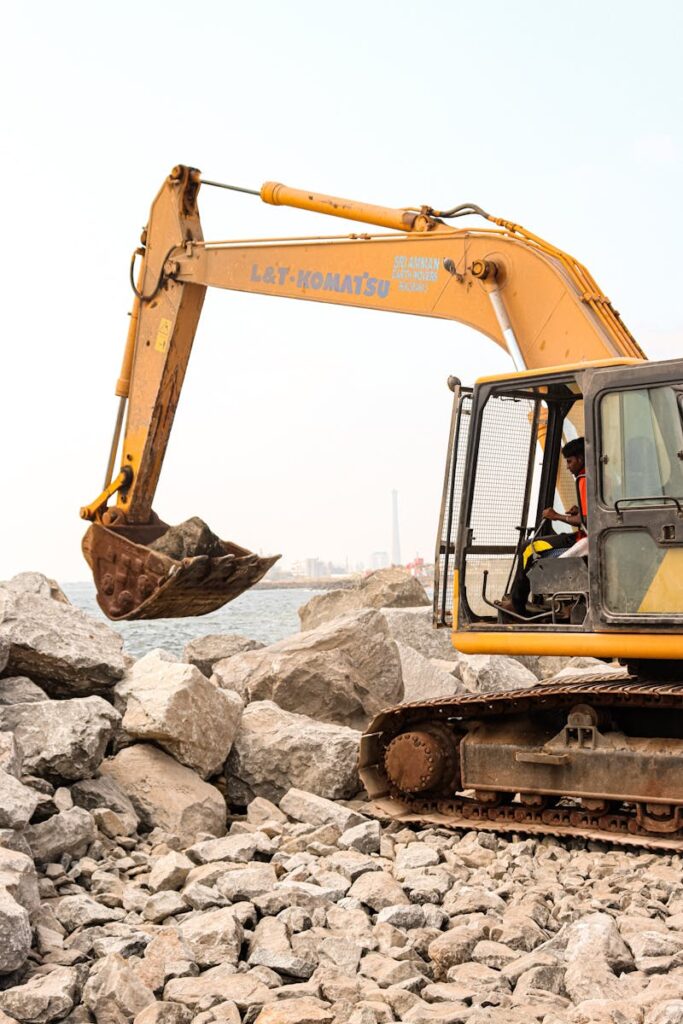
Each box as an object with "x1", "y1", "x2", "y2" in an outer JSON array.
[{"x1": 0, "y1": 0, "x2": 683, "y2": 581}]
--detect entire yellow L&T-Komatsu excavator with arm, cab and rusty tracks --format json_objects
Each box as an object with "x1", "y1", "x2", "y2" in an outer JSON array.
[{"x1": 81, "y1": 166, "x2": 683, "y2": 850}]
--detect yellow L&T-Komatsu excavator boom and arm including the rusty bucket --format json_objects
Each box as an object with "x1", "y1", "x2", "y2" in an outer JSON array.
[{"x1": 81, "y1": 166, "x2": 644, "y2": 618}]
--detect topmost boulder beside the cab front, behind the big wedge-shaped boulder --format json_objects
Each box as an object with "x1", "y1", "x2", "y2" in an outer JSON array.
[{"x1": 299, "y1": 568, "x2": 431, "y2": 630}]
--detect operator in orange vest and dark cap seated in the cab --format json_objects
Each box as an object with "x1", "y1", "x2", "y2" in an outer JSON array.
[{"x1": 498, "y1": 437, "x2": 588, "y2": 615}]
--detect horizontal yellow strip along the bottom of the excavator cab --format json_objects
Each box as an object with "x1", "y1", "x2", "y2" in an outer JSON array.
[{"x1": 451, "y1": 631, "x2": 683, "y2": 659}]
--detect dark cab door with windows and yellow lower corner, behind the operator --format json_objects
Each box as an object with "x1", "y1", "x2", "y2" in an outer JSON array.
[{"x1": 584, "y1": 359, "x2": 683, "y2": 632}]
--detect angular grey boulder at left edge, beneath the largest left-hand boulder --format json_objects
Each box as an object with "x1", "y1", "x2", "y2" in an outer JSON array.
[{"x1": 0, "y1": 700, "x2": 121, "y2": 779}]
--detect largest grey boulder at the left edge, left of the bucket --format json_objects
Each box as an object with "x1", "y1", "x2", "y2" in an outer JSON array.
[{"x1": 0, "y1": 588, "x2": 126, "y2": 696}]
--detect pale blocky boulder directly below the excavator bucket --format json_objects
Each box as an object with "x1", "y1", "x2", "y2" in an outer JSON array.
[{"x1": 116, "y1": 650, "x2": 243, "y2": 778}]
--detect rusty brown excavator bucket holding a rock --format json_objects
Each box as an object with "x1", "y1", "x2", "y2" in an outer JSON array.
[{"x1": 82, "y1": 519, "x2": 280, "y2": 622}]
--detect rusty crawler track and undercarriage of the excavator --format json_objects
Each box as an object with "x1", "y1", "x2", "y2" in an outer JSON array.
[{"x1": 360, "y1": 671, "x2": 683, "y2": 850}]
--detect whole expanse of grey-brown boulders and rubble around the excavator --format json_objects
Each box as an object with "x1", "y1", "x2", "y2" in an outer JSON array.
[{"x1": 0, "y1": 573, "x2": 651, "y2": 1024}]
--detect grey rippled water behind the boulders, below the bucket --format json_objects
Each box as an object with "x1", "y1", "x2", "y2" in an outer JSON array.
[{"x1": 61, "y1": 583, "x2": 318, "y2": 657}]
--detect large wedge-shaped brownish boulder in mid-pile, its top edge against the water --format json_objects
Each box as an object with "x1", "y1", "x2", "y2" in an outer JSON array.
[{"x1": 213, "y1": 609, "x2": 403, "y2": 729}]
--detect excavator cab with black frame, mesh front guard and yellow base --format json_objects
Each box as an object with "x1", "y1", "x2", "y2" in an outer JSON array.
[{"x1": 434, "y1": 360, "x2": 683, "y2": 667}]
